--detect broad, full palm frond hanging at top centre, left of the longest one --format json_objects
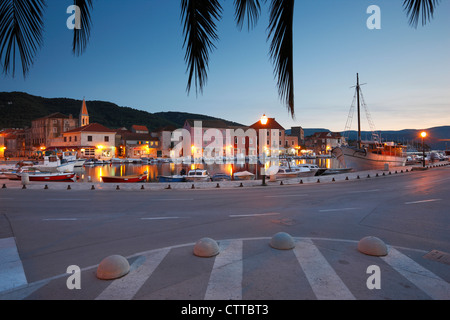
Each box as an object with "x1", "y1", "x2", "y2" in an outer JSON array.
[{"x1": 181, "y1": 0, "x2": 222, "y2": 93}]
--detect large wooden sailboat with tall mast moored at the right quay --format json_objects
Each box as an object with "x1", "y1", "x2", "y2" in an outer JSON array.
[{"x1": 331, "y1": 74, "x2": 406, "y2": 171}]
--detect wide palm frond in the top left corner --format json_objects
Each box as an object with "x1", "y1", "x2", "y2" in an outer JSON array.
[{"x1": 0, "y1": 0, "x2": 46, "y2": 77}]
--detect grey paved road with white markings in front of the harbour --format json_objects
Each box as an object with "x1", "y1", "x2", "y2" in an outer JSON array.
[{"x1": 0, "y1": 167, "x2": 450, "y2": 300}]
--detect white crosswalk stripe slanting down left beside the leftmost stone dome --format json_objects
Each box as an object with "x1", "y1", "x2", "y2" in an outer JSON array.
[{"x1": 95, "y1": 249, "x2": 170, "y2": 300}]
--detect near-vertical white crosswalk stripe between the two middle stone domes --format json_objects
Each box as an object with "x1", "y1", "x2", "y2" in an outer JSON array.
[{"x1": 205, "y1": 240, "x2": 244, "y2": 300}]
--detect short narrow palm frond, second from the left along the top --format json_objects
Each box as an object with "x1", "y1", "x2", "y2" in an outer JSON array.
[{"x1": 72, "y1": 0, "x2": 93, "y2": 56}]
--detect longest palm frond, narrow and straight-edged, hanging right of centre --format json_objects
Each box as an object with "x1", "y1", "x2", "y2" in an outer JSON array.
[{"x1": 268, "y1": 0, "x2": 294, "y2": 117}]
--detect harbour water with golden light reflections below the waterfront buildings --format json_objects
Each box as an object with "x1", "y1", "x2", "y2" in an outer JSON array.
[{"x1": 76, "y1": 158, "x2": 340, "y2": 182}]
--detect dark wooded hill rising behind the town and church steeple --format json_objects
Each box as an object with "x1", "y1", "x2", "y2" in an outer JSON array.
[{"x1": 0, "y1": 92, "x2": 243, "y2": 131}]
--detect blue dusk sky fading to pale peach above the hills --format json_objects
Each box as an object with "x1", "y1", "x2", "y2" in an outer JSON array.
[{"x1": 0, "y1": 0, "x2": 450, "y2": 131}]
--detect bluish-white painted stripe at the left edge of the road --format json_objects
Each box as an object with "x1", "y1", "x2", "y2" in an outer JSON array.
[{"x1": 0, "y1": 238, "x2": 27, "y2": 292}]
